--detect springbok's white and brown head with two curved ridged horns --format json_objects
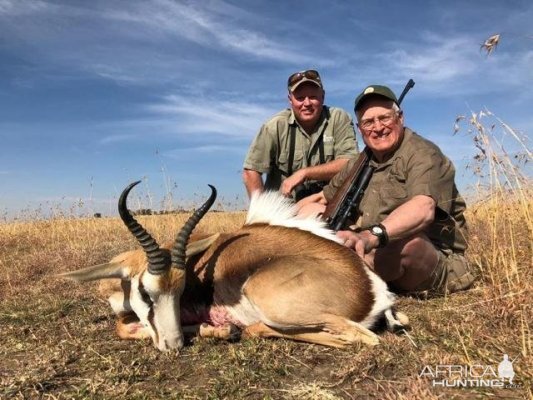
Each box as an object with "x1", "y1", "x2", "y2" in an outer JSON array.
[{"x1": 58, "y1": 181, "x2": 216, "y2": 351}]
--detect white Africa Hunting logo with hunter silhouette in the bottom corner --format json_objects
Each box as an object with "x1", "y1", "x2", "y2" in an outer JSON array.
[{"x1": 419, "y1": 354, "x2": 521, "y2": 388}]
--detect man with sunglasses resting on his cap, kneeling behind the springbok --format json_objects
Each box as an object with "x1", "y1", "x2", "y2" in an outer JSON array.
[{"x1": 242, "y1": 70, "x2": 357, "y2": 200}]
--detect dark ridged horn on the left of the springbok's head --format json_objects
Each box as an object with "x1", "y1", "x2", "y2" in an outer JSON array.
[{"x1": 118, "y1": 181, "x2": 170, "y2": 275}]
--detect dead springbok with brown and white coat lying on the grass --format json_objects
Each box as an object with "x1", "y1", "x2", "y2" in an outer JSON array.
[{"x1": 62, "y1": 181, "x2": 408, "y2": 351}]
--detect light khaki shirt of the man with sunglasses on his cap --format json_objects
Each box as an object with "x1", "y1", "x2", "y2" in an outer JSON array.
[{"x1": 244, "y1": 106, "x2": 358, "y2": 190}]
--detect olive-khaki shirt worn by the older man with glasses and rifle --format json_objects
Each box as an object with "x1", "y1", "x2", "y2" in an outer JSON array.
[{"x1": 324, "y1": 128, "x2": 467, "y2": 253}]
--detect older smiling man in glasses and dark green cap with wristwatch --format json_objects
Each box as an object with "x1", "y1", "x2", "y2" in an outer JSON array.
[{"x1": 299, "y1": 85, "x2": 474, "y2": 294}]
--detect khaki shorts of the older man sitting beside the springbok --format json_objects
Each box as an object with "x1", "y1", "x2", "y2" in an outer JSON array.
[{"x1": 406, "y1": 250, "x2": 476, "y2": 295}]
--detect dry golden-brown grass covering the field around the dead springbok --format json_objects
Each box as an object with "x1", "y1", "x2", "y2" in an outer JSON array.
[{"x1": 0, "y1": 115, "x2": 533, "y2": 399}]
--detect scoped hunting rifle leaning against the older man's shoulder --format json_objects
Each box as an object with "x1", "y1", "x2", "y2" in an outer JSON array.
[{"x1": 322, "y1": 79, "x2": 415, "y2": 231}]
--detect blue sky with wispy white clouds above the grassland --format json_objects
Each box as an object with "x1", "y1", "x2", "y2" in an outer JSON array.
[{"x1": 0, "y1": 0, "x2": 533, "y2": 216}]
